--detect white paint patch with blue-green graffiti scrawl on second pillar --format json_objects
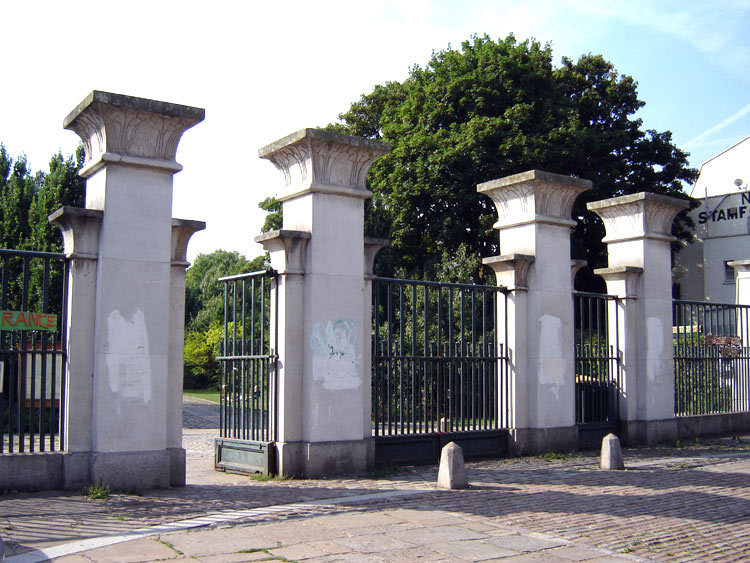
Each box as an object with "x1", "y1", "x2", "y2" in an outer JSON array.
[{"x1": 310, "y1": 319, "x2": 362, "y2": 391}]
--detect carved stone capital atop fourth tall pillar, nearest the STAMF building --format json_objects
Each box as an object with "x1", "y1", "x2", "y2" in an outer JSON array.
[{"x1": 586, "y1": 192, "x2": 690, "y2": 242}]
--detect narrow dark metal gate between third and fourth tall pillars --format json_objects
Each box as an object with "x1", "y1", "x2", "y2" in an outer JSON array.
[{"x1": 573, "y1": 292, "x2": 620, "y2": 448}]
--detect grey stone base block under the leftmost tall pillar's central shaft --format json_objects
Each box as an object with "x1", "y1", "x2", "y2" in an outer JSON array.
[{"x1": 91, "y1": 450, "x2": 171, "y2": 491}]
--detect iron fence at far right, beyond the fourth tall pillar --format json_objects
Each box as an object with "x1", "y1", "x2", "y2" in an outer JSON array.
[{"x1": 672, "y1": 300, "x2": 750, "y2": 416}]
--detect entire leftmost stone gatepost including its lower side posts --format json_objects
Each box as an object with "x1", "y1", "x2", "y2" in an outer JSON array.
[{"x1": 52, "y1": 91, "x2": 204, "y2": 489}]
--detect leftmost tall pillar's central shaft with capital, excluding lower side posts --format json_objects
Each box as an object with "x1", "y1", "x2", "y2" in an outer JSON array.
[{"x1": 64, "y1": 91, "x2": 204, "y2": 489}]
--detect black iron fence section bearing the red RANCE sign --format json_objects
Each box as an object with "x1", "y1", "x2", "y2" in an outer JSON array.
[{"x1": 0, "y1": 249, "x2": 68, "y2": 453}]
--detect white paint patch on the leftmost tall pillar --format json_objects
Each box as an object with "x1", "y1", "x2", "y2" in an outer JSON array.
[{"x1": 105, "y1": 309, "x2": 152, "y2": 403}]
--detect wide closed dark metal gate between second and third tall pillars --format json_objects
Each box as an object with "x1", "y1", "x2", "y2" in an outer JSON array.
[{"x1": 372, "y1": 278, "x2": 508, "y2": 465}]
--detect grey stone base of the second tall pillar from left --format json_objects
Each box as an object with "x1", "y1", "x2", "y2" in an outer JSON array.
[{"x1": 276, "y1": 438, "x2": 375, "y2": 477}]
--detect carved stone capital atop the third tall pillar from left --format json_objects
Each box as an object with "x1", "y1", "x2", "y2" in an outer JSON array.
[{"x1": 477, "y1": 170, "x2": 592, "y2": 230}]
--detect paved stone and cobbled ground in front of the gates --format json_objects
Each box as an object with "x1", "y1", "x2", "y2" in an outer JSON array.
[{"x1": 0, "y1": 398, "x2": 750, "y2": 562}]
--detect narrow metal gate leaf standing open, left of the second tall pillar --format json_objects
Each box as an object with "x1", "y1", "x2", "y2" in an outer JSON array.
[{"x1": 215, "y1": 270, "x2": 278, "y2": 474}]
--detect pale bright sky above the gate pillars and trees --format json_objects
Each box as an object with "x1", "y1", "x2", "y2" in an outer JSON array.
[{"x1": 0, "y1": 0, "x2": 750, "y2": 259}]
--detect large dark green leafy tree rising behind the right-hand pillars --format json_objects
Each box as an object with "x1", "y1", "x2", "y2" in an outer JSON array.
[{"x1": 329, "y1": 35, "x2": 696, "y2": 281}]
